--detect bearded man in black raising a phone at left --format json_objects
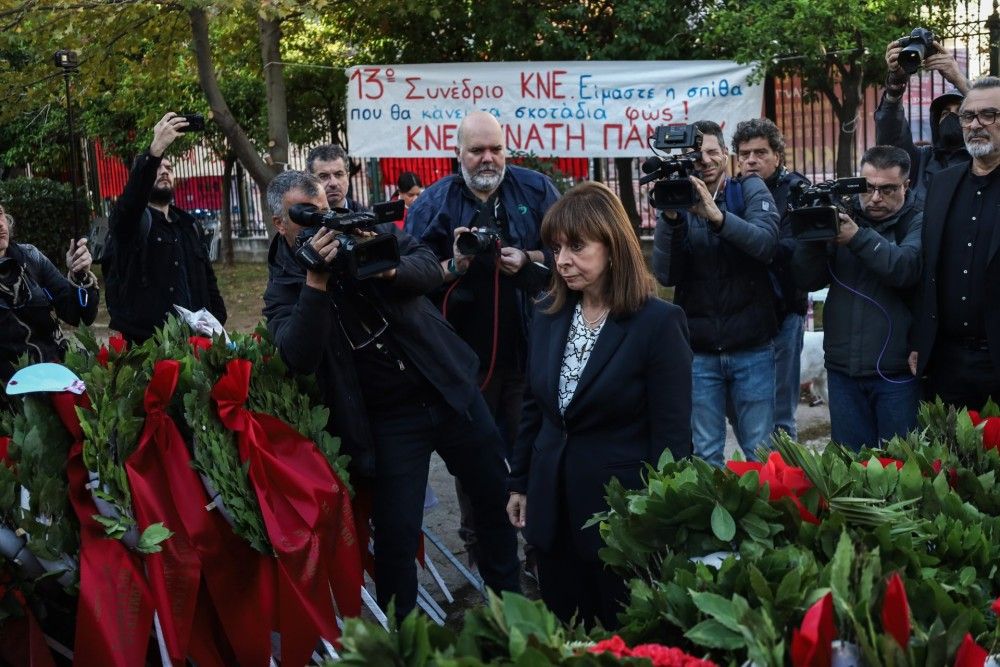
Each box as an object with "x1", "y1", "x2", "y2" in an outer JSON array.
[{"x1": 103, "y1": 111, "x2": 226, "y2": 343}]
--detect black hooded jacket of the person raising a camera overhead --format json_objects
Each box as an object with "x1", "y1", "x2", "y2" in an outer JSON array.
[{"x1": 875, "y1": 90, "x2": 972, "y2": 209}]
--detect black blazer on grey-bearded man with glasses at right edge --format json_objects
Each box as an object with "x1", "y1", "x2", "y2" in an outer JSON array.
[{"x1": 913, "y1": 164, "x2": 1000, "y2": 376}]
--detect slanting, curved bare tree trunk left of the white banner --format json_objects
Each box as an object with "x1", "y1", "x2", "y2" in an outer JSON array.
[{"x1": 188, "y1": 7, "x2": 275, "y2": 192}]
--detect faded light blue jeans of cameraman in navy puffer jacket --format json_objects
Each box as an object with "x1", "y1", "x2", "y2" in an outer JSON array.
[{"x1": 691, "y1": 343, "x2": 774, "y2": 466}]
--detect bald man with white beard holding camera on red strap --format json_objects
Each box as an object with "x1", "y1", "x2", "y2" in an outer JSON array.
[{"x1": 406, "y1": 111, "x2": 559, "y2": 576}]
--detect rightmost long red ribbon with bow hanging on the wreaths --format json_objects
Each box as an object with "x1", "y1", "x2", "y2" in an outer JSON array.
[{"x1": 212, "y1": 359, "x2": 362, "y2": 665}]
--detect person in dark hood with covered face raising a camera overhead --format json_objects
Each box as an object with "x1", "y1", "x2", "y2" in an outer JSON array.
[{"x1": 875, "y1": 34, "x2": 971, "y2": 208}]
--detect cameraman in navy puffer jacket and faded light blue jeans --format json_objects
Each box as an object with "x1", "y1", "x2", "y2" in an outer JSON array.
[{"x1": 653, "y1": 121, "x2": 779, "y2": 466}]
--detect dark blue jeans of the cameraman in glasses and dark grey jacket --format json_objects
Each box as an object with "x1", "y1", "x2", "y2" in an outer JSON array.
[{"x1": 827, "y1": 369, "x2": 920, "y2": 451}]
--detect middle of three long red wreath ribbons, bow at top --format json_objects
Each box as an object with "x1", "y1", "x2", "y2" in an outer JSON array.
[{"x1": 125, "y1": 359, "x2": 273, "y2": 666}]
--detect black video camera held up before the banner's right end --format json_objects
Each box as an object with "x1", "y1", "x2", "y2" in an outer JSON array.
[{"x1": 639, "y1": 125, "x2": 702, "y2": 210}]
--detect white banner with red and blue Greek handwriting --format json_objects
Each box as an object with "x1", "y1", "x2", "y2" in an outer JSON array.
[{"x1": 347, "y1": 60, "x2": 764, "y2": 157}]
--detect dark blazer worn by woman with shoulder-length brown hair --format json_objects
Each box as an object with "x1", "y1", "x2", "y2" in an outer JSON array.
[{"x1": 508, "y1": 298, "x2": 692, "y2": 558}]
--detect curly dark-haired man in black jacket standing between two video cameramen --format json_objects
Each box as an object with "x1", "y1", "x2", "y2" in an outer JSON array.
[{"x1": 733, "y1": 118, "x2": 809, "y2": 440}]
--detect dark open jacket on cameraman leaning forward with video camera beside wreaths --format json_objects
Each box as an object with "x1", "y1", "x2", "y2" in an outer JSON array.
[{"x1": 263, "y1": 222, "x2": 479, "y2": 472}]
